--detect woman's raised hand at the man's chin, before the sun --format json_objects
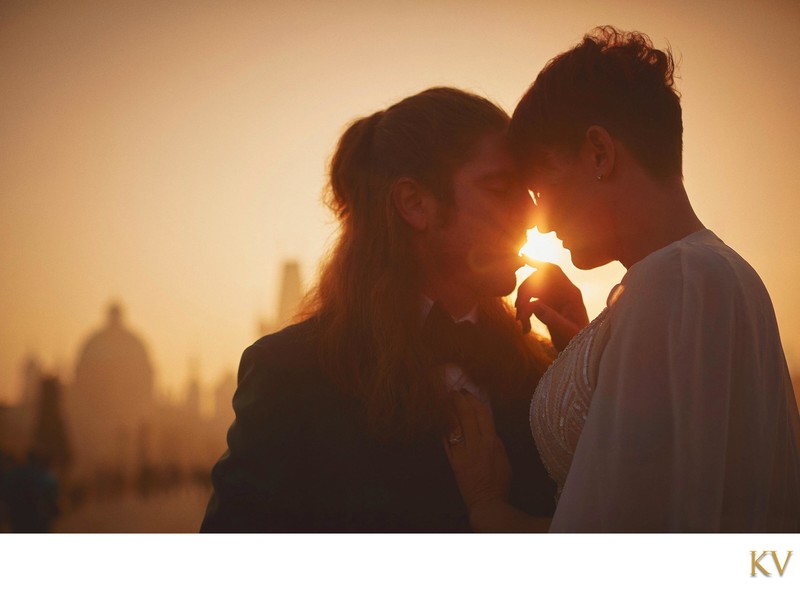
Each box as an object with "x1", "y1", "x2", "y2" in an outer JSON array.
[{"x1": 514, "y1": 258, "x2": 589, "y2": 351}]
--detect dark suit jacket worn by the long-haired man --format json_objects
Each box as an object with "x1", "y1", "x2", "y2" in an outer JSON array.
[{"x1": 201, "y1": 320, "x2": 555, "y2": 532}]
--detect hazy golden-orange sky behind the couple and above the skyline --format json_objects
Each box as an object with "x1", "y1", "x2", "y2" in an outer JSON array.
[{"x1": 0, "y1": 0, "x2": 800, "y2": 400}]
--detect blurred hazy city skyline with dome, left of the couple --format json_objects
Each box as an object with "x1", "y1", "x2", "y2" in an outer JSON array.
[{"x1": 0, "y1": 253, "x2": 303, "y2": 532}]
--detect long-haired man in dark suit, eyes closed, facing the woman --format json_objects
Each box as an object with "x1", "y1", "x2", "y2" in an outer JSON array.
[{"x1": 201, "y1": 88, "x2": 580, "y2": 532}]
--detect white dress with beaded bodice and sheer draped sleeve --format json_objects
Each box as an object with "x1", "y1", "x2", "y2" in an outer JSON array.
[{"x1": 530, "y1": 230, "x2": 800, "y2": 532}]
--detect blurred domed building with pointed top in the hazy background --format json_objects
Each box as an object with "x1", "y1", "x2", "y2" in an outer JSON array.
[{"x1": 70, "y1": 303, "x2": 154, "y2": 476}]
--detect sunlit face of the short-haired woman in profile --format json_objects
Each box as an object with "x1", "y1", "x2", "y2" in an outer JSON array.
[{"x1": 524, "y1": 150, "x2": 618, "y2": 270}]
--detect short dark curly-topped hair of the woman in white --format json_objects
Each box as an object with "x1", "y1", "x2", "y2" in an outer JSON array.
[{"x1": 510, "y1": 26, "x2": 683, "y2": 180}]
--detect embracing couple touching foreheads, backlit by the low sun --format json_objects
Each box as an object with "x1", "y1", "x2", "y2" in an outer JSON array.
[{"x1": 201, "y1": 27, "x2": 800, "y2": 533}]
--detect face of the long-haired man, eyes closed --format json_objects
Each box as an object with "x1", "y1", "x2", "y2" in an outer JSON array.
[{"x1": 432, "y1": 133, "x2": 533, "y2": 296}]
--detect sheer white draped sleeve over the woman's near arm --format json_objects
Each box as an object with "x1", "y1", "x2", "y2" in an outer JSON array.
[{"x1": 551, "y1": 247, "x2": 737, "y2": 532}]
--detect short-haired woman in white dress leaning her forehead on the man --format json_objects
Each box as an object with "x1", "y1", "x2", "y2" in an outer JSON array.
[{"x1": 446, "y1": 27, "x2": 800, "y2": 532}]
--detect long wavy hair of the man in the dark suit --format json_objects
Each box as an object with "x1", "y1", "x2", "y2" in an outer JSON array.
[{"x1": 302, "y1": 87, "x2": 550, "y2": 439}]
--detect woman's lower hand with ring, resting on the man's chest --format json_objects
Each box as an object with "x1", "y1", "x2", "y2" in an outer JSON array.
[{"x1": 444, "y1": 390, "x2": 511, "y2": 515}]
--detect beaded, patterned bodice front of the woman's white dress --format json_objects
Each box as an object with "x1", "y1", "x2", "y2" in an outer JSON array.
[{"x1": 530, "y1": 291, "x2": 614, "y2": 495}]
